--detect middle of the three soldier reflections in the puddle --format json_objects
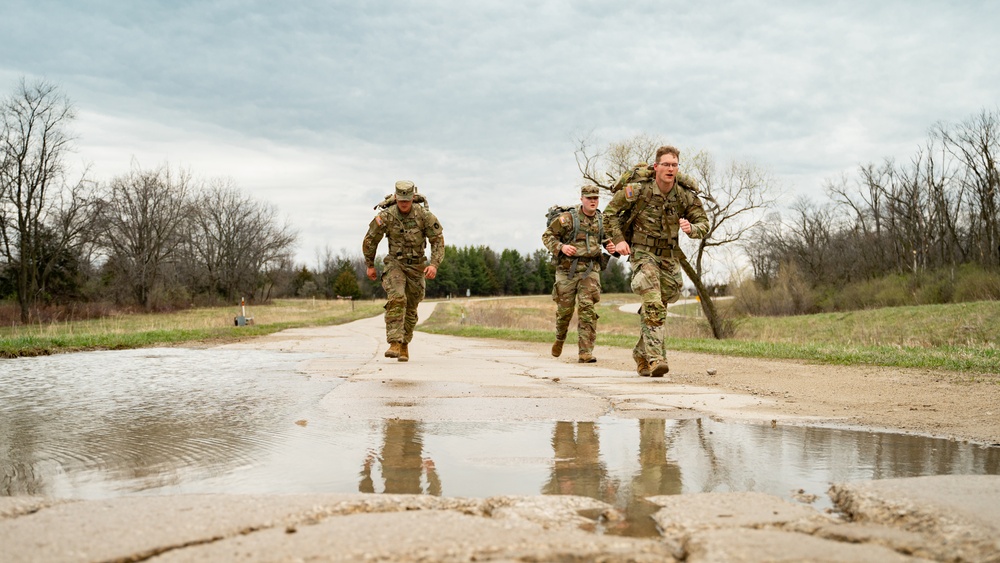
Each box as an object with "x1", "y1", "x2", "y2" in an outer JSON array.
[{"x1": 542, "y1": 422, "x2": 615, "y2": 502}]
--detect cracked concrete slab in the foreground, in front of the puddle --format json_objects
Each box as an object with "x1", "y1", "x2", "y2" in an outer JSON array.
[{"x1": 0, "y1": 476, "x2": 1000, "y2": 563}]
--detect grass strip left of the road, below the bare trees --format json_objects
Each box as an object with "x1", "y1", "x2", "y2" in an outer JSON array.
[{"x1": 0, "y1": 299, "x2": 384, "y2": 358}]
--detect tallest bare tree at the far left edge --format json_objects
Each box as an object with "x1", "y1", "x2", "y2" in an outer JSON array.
[{"x1": 0, "y1": 79, "x2": 89, "y2": 323}]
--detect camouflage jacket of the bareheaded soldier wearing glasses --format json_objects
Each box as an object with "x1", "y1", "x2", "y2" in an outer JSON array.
[{"x1": 604, "y1": 182, "x2": 709, "y2": 258}]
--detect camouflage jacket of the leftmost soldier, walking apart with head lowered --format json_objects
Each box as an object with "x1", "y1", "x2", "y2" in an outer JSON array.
[{"x1": 361, "y1": 205, "x2": 444, "y2": 268}]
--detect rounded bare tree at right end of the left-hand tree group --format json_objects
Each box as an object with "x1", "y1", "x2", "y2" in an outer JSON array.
[{"x1": 189, "y1": 178, "x2": 298, "y2": 301}]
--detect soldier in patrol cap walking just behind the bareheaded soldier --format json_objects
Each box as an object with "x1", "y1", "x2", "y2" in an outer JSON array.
[{"x1": 542, "y1": 186, "x2": 614, "y2": 363}]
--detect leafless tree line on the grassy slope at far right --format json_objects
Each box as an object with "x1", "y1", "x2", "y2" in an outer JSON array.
[{"x1": 742, "y1": 110, "x2": 1000, "y2": 312}]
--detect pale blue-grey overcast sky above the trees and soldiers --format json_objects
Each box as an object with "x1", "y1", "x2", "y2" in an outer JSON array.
[{"x1": 0, "y1": 0, "x2": 1000, "y2": 266}]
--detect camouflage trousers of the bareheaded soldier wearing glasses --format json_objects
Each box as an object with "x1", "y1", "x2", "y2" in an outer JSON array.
[{"x1": 632, "y1": 253, "x2": 684, "y2": 362}]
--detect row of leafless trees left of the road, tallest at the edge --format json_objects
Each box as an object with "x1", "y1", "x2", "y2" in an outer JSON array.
[{"x1": 0, "y1": 79, "x2": 296, "y2": 323}]
